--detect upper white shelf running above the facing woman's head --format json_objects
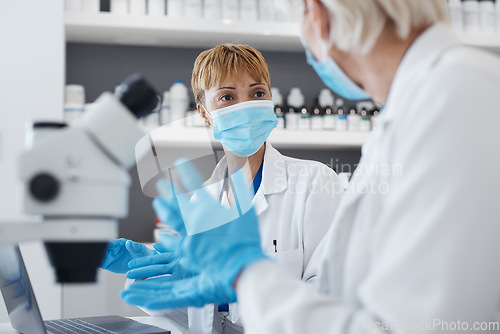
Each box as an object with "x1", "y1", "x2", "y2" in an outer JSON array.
[{"x1": 65, "y1": 12, "x2": 303, "y2": 52}]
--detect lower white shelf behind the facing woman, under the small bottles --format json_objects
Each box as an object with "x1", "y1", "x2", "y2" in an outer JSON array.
[{"x1": 144, "y1": 126, "x2": 370, "y2": 149}]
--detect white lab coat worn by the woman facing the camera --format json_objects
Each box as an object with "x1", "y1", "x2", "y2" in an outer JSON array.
[{"x1": 143, "y1": 143, "x2": 343, "y2": 334}]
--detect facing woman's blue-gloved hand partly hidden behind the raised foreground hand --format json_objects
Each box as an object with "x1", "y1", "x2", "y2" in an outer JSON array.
[{"x1": 126, "y1": 234, "x2": 194, "y2": 280}]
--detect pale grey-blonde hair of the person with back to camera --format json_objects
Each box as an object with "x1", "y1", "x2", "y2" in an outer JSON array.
[{"x1": 321, "y1": 0, "x2": 450, "y2": 54}]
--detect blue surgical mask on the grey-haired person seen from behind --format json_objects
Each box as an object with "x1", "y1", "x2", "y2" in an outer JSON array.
[{"x1": 302, "y1": 41, "x2": 371, "y2": 100}]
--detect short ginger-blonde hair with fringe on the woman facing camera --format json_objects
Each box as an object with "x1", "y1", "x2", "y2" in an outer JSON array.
[{"x1": 191, "y1": 44, "x2": 271, "y2": 104}]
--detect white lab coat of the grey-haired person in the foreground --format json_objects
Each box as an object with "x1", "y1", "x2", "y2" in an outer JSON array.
[{"x1": 237, "y1": 24, "x2": 500, "y2": 334}]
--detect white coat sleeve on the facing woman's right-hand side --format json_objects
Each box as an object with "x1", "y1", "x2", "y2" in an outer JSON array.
[{"x1": 302, "y1": 163, "x2": 344, "y2": 282}]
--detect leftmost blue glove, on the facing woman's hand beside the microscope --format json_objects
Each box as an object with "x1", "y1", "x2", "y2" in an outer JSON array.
[{"x1": 101, "y1": 238, "x2": 157, "y2": 274}]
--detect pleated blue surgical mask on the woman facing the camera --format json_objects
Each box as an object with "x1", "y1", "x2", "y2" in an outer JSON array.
[{"x1": 206, "y1": 100, "x2": 278, "y2": 157}]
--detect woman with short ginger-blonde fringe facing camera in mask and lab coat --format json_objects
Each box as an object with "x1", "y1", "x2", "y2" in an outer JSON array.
[{"x1": 103, "y1": 44, "x2": 343, "y2": 334}]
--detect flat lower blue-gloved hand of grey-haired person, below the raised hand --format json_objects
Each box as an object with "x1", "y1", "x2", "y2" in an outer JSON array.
[{"x1": 121, "y1": 274, "x2": 236, "y2": 310}]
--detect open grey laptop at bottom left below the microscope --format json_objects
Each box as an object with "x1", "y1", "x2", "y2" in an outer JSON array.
[{"x1": 0, "y1": 245, "x2": 170, "y2": 334}]
